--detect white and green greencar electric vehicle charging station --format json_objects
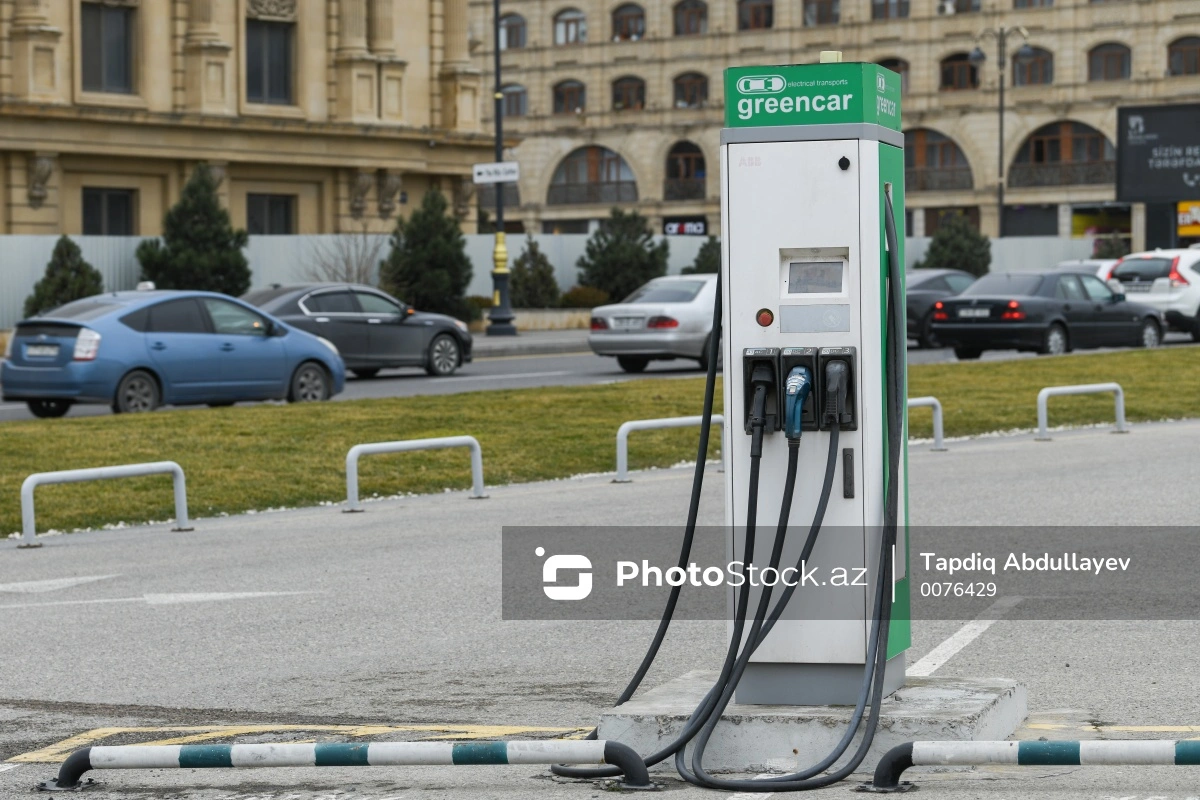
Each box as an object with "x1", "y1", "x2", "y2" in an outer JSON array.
[{"x1": 720, "y1": 54, "x2": 910, "y2": 705}]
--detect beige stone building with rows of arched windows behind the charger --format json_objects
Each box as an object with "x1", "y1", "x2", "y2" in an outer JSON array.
[{"x1": 472, "y1": 0, "x2": 1200, "y2": 247}]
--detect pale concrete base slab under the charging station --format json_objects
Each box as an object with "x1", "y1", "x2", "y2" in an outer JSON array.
[{"x1": 600, "y1": 670, "x2": 1027, "y2": 772}]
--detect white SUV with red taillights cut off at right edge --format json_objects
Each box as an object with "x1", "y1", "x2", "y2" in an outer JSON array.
[{"x1": 1108, "y1": 248, "x2": 1200, "y2": 342}]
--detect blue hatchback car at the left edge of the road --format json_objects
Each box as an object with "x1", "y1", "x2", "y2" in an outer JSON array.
[{"x1": 0, "y1": 290, "x2": 346, "y2": 417}]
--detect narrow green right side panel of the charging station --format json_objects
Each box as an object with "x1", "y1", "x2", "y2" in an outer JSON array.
[{"x1": 878, "y1": 143, "x2": 912, "y2": 658}]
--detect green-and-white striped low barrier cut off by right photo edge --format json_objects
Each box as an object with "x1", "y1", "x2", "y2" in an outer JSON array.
[{"x1": 858, "y1": 739, "x2": 1200, "y2": 792}]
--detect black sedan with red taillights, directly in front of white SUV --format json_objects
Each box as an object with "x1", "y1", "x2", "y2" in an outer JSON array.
[{"x1": 932, "y1": 271, "x2": 1163, "y2": 359}]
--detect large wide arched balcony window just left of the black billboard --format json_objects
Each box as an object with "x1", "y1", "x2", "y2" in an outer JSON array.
[{"x1": 1008, "y1": 122, "x2": 1116, "y2": 186}]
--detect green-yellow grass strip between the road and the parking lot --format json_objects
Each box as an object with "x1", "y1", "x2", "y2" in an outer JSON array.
[{"x1": 0, "y1": 347, "x2": 1200, "y2": 535}]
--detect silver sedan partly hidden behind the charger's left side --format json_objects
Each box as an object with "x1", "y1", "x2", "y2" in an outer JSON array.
[{"x1": 588, "y1": 275, "x2": 716, "y2": 372}]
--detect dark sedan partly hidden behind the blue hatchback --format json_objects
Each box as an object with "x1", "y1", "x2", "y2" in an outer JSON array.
[{"x1": 242, "y1": 283, "x2": 472, "y2": 378}]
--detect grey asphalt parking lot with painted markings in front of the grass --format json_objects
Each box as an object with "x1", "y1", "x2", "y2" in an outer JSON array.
[{"x1": 0, "y1": 421, "x2": 1200, "y2": 800}]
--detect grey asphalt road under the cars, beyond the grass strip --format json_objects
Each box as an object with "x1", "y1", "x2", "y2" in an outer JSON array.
[{"x1": 0, "y1": 331, "x2": 1190, "y2": 422}]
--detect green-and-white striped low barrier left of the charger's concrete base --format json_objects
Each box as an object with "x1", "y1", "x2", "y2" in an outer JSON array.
[{"x1": 37, "y1": 739, "x2": 655, "y2": 792}]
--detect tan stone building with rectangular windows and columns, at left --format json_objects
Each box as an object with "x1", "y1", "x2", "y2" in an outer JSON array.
[{"x1": 0, "y1": 0, "x2": 492, "y2": 235}]
